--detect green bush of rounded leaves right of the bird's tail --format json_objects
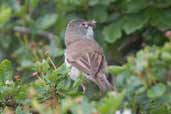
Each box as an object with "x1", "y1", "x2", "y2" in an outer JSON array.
[{"x1": 107, "y1": 43, "x2": 171, "y2": 114}]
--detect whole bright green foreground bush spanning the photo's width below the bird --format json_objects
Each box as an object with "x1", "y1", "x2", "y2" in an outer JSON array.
[{"x1": 0, "y1": 43, "x2": 171, "y2": 114}]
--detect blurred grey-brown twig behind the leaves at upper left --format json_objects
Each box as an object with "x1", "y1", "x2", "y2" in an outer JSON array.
[{"x1": 13, "y1": 26, "x2": 56, "y2": 40}]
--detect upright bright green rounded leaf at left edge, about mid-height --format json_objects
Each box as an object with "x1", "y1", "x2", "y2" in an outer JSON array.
[{"x1": 0, "y1": 59, "x2": 13, "y2": 81}]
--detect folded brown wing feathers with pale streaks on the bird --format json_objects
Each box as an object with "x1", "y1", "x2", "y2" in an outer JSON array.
[{"x1": 68, "y1": 51, "x2": 104, "y2": 76}]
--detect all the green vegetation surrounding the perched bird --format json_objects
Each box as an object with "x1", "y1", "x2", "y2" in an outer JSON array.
[{"x1": 0, "y1": 0, "x2": 171, "y2": 114}]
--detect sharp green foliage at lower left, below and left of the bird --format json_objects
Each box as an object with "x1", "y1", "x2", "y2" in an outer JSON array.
[{"x1": 0, "y1": 60, "x2": 124, "y2": 114}]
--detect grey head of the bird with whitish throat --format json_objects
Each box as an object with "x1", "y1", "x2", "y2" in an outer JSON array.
[{"x1": 65, "y1": 19, "x2": 95, "y2": 45}]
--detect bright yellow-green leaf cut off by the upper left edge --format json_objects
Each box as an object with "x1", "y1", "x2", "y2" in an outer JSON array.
[{"x1": 0, "y1": 7, "x2": 12, "y2": 27}]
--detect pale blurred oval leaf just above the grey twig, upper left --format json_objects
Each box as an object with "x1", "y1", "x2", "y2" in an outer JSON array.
[{"x1": 34, "y1": 14, "x2": 57, "y2": 30}]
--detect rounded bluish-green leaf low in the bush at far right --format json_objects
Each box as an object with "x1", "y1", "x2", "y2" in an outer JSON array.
[{"x1": 147, "y1": 83, "x2": 166, "y2": 98}]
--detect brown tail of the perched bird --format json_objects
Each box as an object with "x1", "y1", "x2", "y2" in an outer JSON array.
[{"x1": 95, "y1": 72, "x2": 113, "y2": 92}]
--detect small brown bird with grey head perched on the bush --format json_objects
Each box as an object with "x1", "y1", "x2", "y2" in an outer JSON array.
[{"x1": 64, "y1": 19, "x2": 112, "y2": 92}]
